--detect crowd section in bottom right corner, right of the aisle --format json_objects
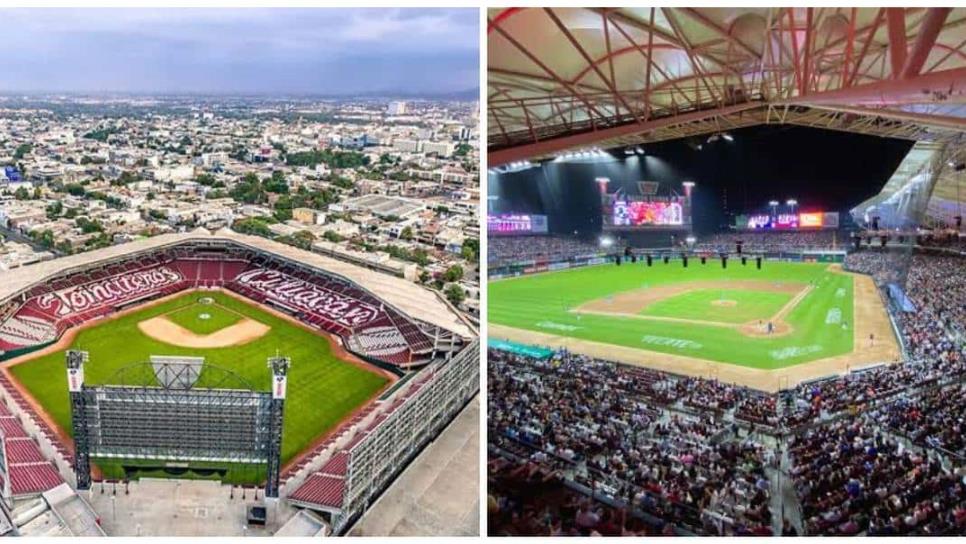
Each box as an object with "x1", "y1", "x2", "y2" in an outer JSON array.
[{"x1": 788, "y1": 417, "x2": 966, "y2": 536}]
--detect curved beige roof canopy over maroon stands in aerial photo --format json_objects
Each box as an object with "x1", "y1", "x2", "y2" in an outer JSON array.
[{"x1": 0, "y1": 229, "x2": 476, "y2": 338}]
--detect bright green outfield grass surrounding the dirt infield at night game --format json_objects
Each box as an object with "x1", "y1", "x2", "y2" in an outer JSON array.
[{"x1": 487, "y1": 260, "x2": 853, "y2": 369}]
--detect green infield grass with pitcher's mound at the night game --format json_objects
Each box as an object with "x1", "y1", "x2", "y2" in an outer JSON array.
[{"x1": 641, "y1": 289, "x2": 794, "y2": 323}]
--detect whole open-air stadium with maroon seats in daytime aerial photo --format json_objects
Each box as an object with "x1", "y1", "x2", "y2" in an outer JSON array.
[{"x1": 0, "y1": 229, "x2": 479, "y2": 536}]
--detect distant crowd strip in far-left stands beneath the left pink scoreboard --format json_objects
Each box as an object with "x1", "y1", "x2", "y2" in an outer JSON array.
[{"x1": 486, "y1": 235, "x2": 604, "y2": 266}]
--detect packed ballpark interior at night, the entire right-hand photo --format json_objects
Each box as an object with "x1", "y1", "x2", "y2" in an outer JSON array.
[{"x1": 487, "y1": 7, "x2": 966, "y2": 536}]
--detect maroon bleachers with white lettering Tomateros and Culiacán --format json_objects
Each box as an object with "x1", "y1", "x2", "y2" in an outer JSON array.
[{"x1": 0, "y1": 244, "x2": 462, "y2": 368}]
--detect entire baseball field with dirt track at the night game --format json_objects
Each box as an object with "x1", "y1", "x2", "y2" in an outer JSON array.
[{"x1": 488, "y1": 258, "x2": 898, "y2": 392}]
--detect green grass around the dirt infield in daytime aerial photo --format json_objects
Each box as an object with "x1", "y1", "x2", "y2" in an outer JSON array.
[{"x1": 10, "y1": 293, "x2": 387, "y2": 482}]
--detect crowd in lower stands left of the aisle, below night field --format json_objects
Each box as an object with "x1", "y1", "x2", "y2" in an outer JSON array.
[{"x1": 487, "y1": 352, "x2": 771, "y2": 534}]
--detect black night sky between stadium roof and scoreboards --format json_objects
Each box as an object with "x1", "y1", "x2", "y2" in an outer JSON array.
[{"x1": 489, "y1": 125, "x2": 913, "y2": 235}]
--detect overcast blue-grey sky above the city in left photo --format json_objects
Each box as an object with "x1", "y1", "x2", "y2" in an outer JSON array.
[{"x1": 0, "y1": 8, "x2": 479, "y2": 94}]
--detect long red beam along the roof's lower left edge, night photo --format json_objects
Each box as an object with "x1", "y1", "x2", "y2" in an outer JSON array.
[{"x1": 486, "y1": 102, "x2": 762, "y2": 167}]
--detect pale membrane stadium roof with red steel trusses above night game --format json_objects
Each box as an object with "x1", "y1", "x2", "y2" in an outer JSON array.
[{"x1": 487, "y1": 7, "x2": 966, "y2": 166}]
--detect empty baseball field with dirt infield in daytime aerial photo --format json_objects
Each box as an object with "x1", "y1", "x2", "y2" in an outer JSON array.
[{"x1": 7, "y1": 291, "x2": 391, "y2": 483}]
